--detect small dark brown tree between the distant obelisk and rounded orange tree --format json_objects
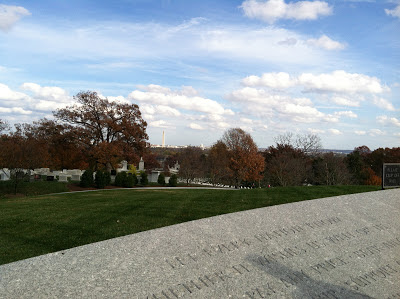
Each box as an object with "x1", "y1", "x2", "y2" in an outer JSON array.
[{"x1": 178, "y1": 146, "x2": 205, "y2": 184}]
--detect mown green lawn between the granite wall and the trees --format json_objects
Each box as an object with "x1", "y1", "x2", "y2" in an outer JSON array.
[{"x1": 0, "y1": 186, "x2": 379, "y2": 264}]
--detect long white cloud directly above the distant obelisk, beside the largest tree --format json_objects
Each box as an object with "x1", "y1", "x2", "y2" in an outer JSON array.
[{"x1": 128, "y1": 85, "x2": 232, "y2": 114}]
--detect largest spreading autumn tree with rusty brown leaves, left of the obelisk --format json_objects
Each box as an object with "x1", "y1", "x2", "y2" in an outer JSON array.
[{"x1": 54, "y1": 91, "x2": 148, "y2": 170}]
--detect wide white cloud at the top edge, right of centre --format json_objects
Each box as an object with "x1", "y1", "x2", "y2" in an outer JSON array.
[{"x1": 241, "y1": 0, "x2": 332, "y2": 23}]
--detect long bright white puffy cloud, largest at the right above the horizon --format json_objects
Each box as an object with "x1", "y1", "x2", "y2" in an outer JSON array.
[{"x1": 298, "y1": 70, "x2": 388, "y2": 94}]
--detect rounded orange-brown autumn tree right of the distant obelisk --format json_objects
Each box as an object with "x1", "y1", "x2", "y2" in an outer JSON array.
[{"x1": 221, "y1": 128, "x2": 265, "y2": 187}]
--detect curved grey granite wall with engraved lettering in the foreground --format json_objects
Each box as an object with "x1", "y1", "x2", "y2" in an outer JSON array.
[{"x1": 0, "y1": 189, "x2": 400, "y2": 299}]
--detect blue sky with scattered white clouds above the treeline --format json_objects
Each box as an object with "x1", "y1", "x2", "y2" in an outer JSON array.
[{"x1": 0, "y1": 0, "x2": 400, "y2": 149}]
